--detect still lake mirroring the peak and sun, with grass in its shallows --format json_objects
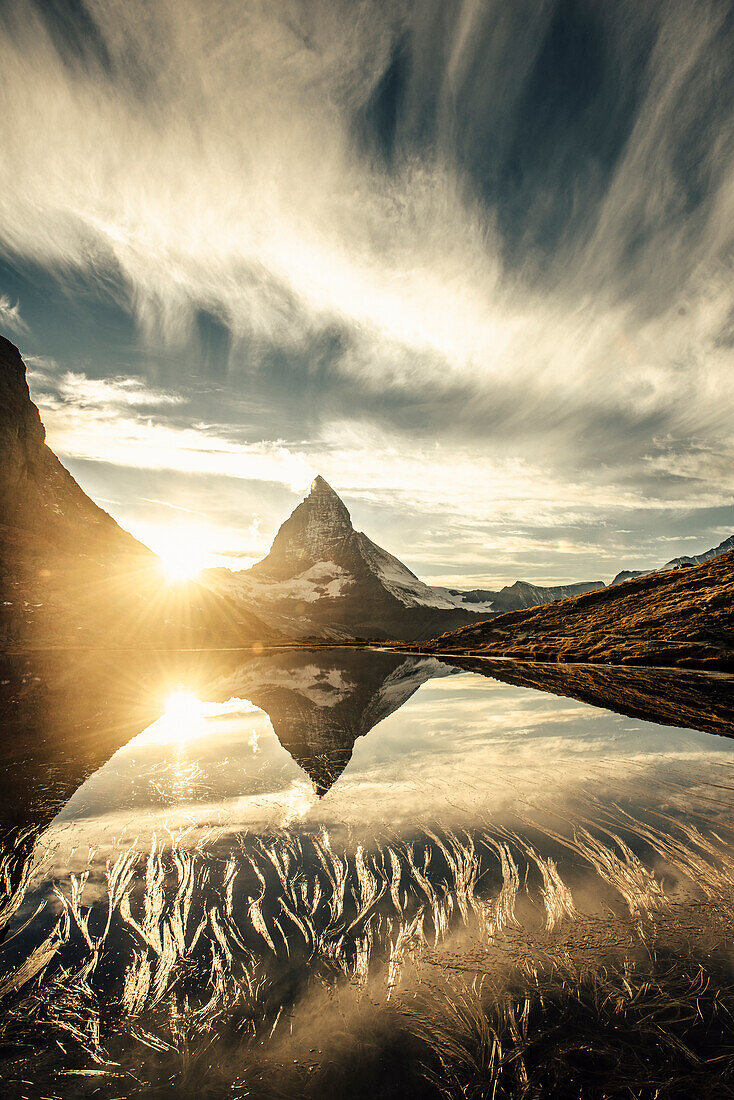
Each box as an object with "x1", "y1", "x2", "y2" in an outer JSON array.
[{"x1": 0, "y1": 649, "x2": 734, "y2": 1098}]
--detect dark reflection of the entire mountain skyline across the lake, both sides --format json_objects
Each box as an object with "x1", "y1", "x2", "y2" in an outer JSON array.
[{"x1": 0, "y1": 648, "x2": 734, "y2": 832}]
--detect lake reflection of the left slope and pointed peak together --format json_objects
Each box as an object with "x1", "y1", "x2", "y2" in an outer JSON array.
[{"x1": 0, "y1": 649, "x2": 448, "y2": 829}]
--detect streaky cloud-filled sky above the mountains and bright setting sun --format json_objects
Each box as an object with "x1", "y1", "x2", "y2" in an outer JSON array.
[{"x1": 0, "y1": 0, "x2": 734, "y2": 587}]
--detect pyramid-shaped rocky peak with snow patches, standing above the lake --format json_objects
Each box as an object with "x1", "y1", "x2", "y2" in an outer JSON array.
[{"x1": 204, "y1": 476, "x2": 602, "y2": 639}]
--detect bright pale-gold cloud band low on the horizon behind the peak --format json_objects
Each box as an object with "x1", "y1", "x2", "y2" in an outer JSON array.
[{"x1": 30, "y1": 360, "x2": 731, "y2": 587}]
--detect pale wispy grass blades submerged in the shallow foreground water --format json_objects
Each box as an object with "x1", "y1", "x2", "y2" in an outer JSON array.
[{"x1": 0, "y1": 806, "x2": 734, "y2": 1100}]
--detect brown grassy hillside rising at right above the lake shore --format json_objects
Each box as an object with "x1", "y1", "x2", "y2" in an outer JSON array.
[{"x1": 413, "y1": 552, "x2": 734, "y2": 670}]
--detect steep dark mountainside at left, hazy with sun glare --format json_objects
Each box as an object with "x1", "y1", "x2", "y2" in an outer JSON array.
[{"x1": 0, "y1": 337, "x2": 274, "y2": 648}]
